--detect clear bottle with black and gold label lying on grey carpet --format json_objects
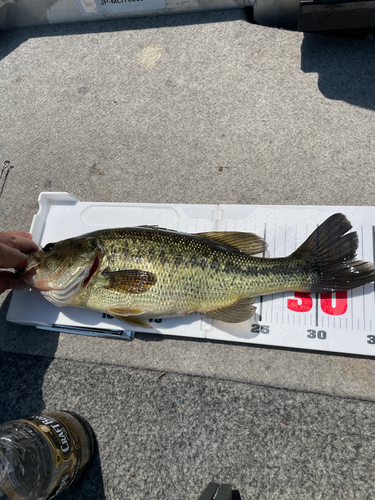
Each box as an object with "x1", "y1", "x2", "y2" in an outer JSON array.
[{"x1": 0, "y1": 410, "x2": 94, "y2": 500}]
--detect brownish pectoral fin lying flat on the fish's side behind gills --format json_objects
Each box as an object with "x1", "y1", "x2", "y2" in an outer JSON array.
[{"x1": 103, "y1": 269, "x2": 156, "y2": 293}]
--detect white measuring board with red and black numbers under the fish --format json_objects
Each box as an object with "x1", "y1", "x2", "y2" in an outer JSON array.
[{"x1": 7, "y1": 193, "x2": 375, "y2": 356}]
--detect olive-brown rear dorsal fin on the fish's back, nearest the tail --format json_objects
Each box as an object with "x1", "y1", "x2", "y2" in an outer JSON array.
[{"x1": 197, "y1": 231, "x2": 267, "y2": 255}]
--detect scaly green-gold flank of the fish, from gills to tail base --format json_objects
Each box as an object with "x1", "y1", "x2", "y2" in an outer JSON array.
[{"x1": 78, "y1": 229, "x2": 296, "y2": 315}]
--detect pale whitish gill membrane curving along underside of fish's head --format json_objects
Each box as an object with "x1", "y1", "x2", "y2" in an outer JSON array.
[{"x1": 37, "y1": 255, "x2": 100, "y2": 307}]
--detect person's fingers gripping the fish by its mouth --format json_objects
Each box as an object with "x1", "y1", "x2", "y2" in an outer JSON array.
[{"x1": 0, "y1": 231, "x2": 39, "y2": 293}]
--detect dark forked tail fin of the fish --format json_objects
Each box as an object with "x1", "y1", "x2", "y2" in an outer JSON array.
[{"x1": 292, "y1": 213, "x2": 375, "y2": 293}]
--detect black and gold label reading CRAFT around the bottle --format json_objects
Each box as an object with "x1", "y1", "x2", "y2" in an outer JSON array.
[{"x1": 22, "y1": 413, "x2": 85, "y2": 499}]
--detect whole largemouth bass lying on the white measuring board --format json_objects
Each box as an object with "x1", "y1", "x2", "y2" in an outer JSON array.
[{"x1": 19, "y1": 214, "x2": 375, "y2": 326}]
